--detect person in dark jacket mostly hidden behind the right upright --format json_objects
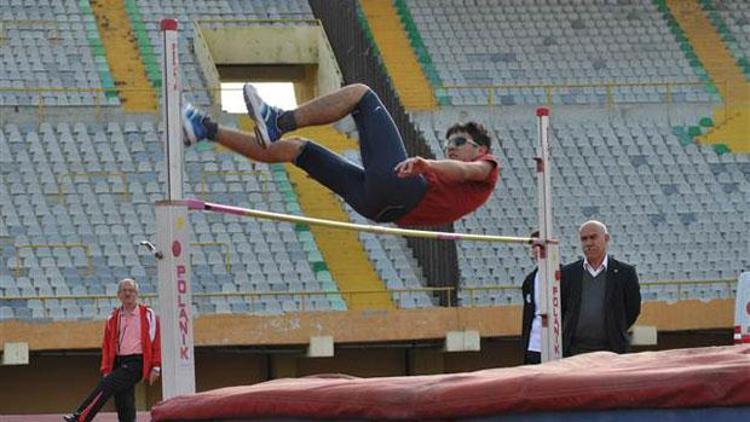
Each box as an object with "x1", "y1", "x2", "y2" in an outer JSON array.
[{"x1": 521, "y1": 231, "x2": 542, "y2": 365}]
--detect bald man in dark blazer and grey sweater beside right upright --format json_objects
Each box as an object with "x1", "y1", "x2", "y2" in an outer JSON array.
[{"x1": 560, "y1": 220, "x2": 641, "y2": 356}]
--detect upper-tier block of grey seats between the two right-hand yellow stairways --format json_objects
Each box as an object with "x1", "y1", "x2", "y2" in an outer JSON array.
[{"x1": 406, "y1": 0, "x2": 719, "y2": 105}]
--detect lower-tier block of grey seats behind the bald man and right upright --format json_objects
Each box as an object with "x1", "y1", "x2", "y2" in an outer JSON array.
[{"x1": 417, "y1": 106, "x2": 750, "y2": 305}]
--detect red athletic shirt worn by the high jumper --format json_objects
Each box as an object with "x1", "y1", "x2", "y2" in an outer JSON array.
[{"x1": 396, "y1": 154, "x2": 500, "y2": 227}]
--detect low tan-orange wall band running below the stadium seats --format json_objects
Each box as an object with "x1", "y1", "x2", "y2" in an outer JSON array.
[{"x1": 0, "y1": 299, "x2": 734, "y2": 351}]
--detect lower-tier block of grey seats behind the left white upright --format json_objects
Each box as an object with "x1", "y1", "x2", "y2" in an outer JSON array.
[{"x1": 0, "y1": 120, "x2": 346, "y2": 319}]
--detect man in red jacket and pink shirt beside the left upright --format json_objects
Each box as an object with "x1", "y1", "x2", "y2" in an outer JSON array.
[{"x1": 64, "y1": 278, "x2": 161, "y2": 422}]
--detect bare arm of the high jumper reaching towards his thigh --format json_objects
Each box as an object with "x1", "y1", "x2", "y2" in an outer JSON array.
[{"x1": 394, "y1": 157, "x2": 492, "y2": 182}]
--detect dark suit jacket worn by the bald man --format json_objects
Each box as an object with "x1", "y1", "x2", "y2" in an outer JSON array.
[{"x1": 560, "y1": 256, "x2": 641, "y2": 356}]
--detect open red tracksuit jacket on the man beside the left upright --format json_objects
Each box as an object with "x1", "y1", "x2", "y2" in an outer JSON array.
[{"x1": 101, "y1": 304, "x2": 161, "y2": 379}]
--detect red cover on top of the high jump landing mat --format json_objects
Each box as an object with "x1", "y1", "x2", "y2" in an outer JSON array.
[{"x1": 151, "y1": 345, "x2": 750, "y2": 421}]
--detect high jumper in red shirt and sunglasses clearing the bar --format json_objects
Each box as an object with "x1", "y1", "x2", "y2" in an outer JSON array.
[{"x1": 182, "y1": 84, "x2": 499, "y2": 227}]
